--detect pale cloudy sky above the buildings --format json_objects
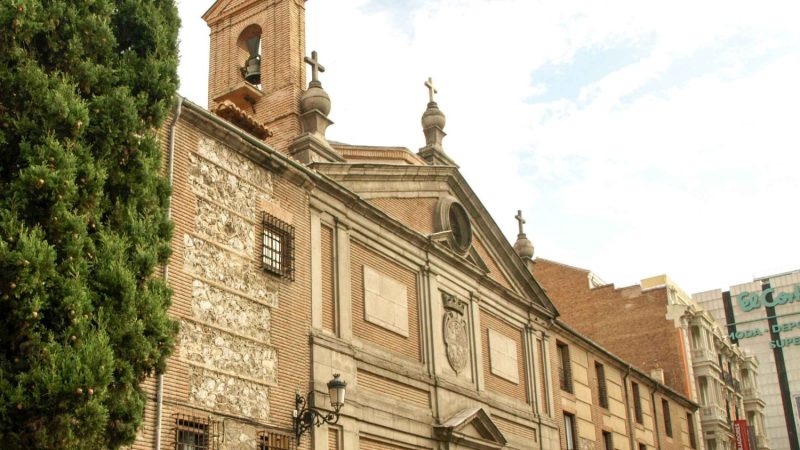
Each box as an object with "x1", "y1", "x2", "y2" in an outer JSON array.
[{"x1": 178, "y1": 0, "x2": 800, "y2": 293}]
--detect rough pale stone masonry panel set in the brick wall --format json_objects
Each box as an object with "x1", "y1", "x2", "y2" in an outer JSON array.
[{"x1": 178, "y1": 138, "x2": 278, "y2": 428}]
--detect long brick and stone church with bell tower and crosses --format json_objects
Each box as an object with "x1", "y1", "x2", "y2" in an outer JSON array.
[{"x1": 133, "y1": 0, "x2": 699, "y2": 450}]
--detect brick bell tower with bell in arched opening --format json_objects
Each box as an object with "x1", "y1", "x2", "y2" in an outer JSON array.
[{"x1": 203, "y1": 0, "x2": 306, "y2": 152}]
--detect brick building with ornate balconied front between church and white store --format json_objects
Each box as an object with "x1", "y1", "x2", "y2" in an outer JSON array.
[{"x1": 531, "y1": 258, "x2": 775, "y2": 450}]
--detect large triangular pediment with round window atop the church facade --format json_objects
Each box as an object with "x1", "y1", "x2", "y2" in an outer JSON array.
[{"x1": 312, "y1": 162, "x2": 558, "y2": 316}]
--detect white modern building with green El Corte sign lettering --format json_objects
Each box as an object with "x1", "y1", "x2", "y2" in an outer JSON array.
[{"x1": 692, "y1": 270, "x2": 800, "y2": 450}]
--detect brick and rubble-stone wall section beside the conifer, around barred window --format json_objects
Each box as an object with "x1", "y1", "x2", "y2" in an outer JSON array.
[{"x1": 133, "y1": 103, "x2": 311, "y2": 449}]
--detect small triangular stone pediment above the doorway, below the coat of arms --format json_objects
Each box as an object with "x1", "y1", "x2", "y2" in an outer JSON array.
[{"x1": 434, "y1": 407, "x2": 507, "y2": 450}]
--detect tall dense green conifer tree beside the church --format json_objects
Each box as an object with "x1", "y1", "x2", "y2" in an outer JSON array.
[{"x1": 0, "y1": 0, "x2": 179, "y2": 449}]
